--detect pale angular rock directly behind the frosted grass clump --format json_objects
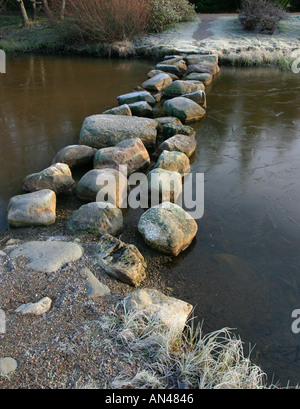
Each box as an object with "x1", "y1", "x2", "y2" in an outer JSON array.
[{"x1": 124, "y1": 288, "x2": 193, "y2": 334}]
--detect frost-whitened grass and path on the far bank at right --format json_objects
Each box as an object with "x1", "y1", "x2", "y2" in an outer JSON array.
[{"x1": 136, "y1": 15, "x2": 300, "y2": 66}]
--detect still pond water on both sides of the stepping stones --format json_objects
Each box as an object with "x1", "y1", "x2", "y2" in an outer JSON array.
[{"x1": 0, "y1": 57, "x2": 300, "y2": 385}]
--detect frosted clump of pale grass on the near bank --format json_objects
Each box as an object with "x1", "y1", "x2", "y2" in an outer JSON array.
[{"x1": 101, "y1": 302, "x2": 267, "y2": 389}]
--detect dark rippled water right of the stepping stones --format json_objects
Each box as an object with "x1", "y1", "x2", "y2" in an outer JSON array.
[{"x1": 166, "y1": 68, "x2": 300, "y2": 384}]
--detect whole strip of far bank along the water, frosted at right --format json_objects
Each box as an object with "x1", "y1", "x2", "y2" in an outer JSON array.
[{"x1": 0, "y1": 13, "x2": 300, "y2": 69}]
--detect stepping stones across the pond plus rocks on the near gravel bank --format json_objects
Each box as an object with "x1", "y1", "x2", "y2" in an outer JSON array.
[{"x1": 0, "y1": 54, "x2": 219, "y2": 374}]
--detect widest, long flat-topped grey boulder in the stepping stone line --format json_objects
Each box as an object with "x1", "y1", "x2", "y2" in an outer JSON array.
[{"x1": 79, "y1": 115, "x2": 157, "y2": 149}]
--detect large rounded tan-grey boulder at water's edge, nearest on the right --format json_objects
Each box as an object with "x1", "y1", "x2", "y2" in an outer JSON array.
[{"x1": 138, "y1": 202, "x2": 198, "y2": 256}]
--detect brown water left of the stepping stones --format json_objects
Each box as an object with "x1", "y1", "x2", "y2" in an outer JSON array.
[{"x1": 0, "y1": 56, "x2": 151, "y2": 229}]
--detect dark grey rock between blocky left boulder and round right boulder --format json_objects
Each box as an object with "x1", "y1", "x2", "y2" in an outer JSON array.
[{"x1": 67, "y1": 202, "x2": 124, "y2": 236}]
